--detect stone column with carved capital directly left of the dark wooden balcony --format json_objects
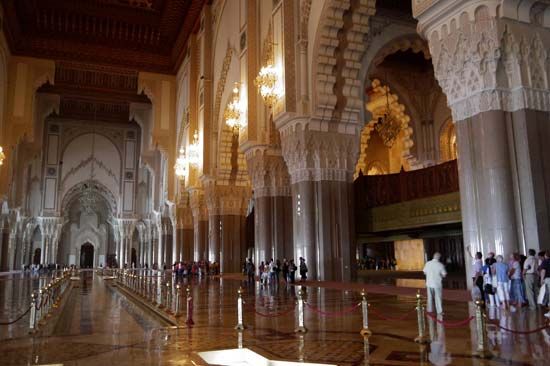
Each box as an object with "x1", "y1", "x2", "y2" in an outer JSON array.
[{"x1": 278, "y1": 118, "x2": 360, "y2": 280}]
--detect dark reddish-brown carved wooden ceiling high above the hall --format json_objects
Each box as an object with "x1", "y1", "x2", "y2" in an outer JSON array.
[{"x1": 2, "y1": 0, "x2": 207, "y2": 74}]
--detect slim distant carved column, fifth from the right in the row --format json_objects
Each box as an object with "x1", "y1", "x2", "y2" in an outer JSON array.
[{"x1": 190, "y1": 188, "x2": 208, "y2": 261}]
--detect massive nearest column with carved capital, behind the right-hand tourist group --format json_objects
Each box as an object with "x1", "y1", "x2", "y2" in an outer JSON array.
[{"x1": 413, "y1": 0, "x2": 550, "y2": 277}]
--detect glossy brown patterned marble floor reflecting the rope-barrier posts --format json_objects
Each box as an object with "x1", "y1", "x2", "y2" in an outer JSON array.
[{"x1": 0, "y1": 272, "x2": 550, "y2": 366}]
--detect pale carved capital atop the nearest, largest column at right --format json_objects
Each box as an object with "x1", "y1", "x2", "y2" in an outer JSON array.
[{"x1": 413, "y1": 0, "x2": 550, "y2": 121}]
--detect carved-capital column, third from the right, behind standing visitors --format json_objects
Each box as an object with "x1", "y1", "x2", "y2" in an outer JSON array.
[{"x1": 246, "y1": 146, "x2": 295, "y2": 274}]
